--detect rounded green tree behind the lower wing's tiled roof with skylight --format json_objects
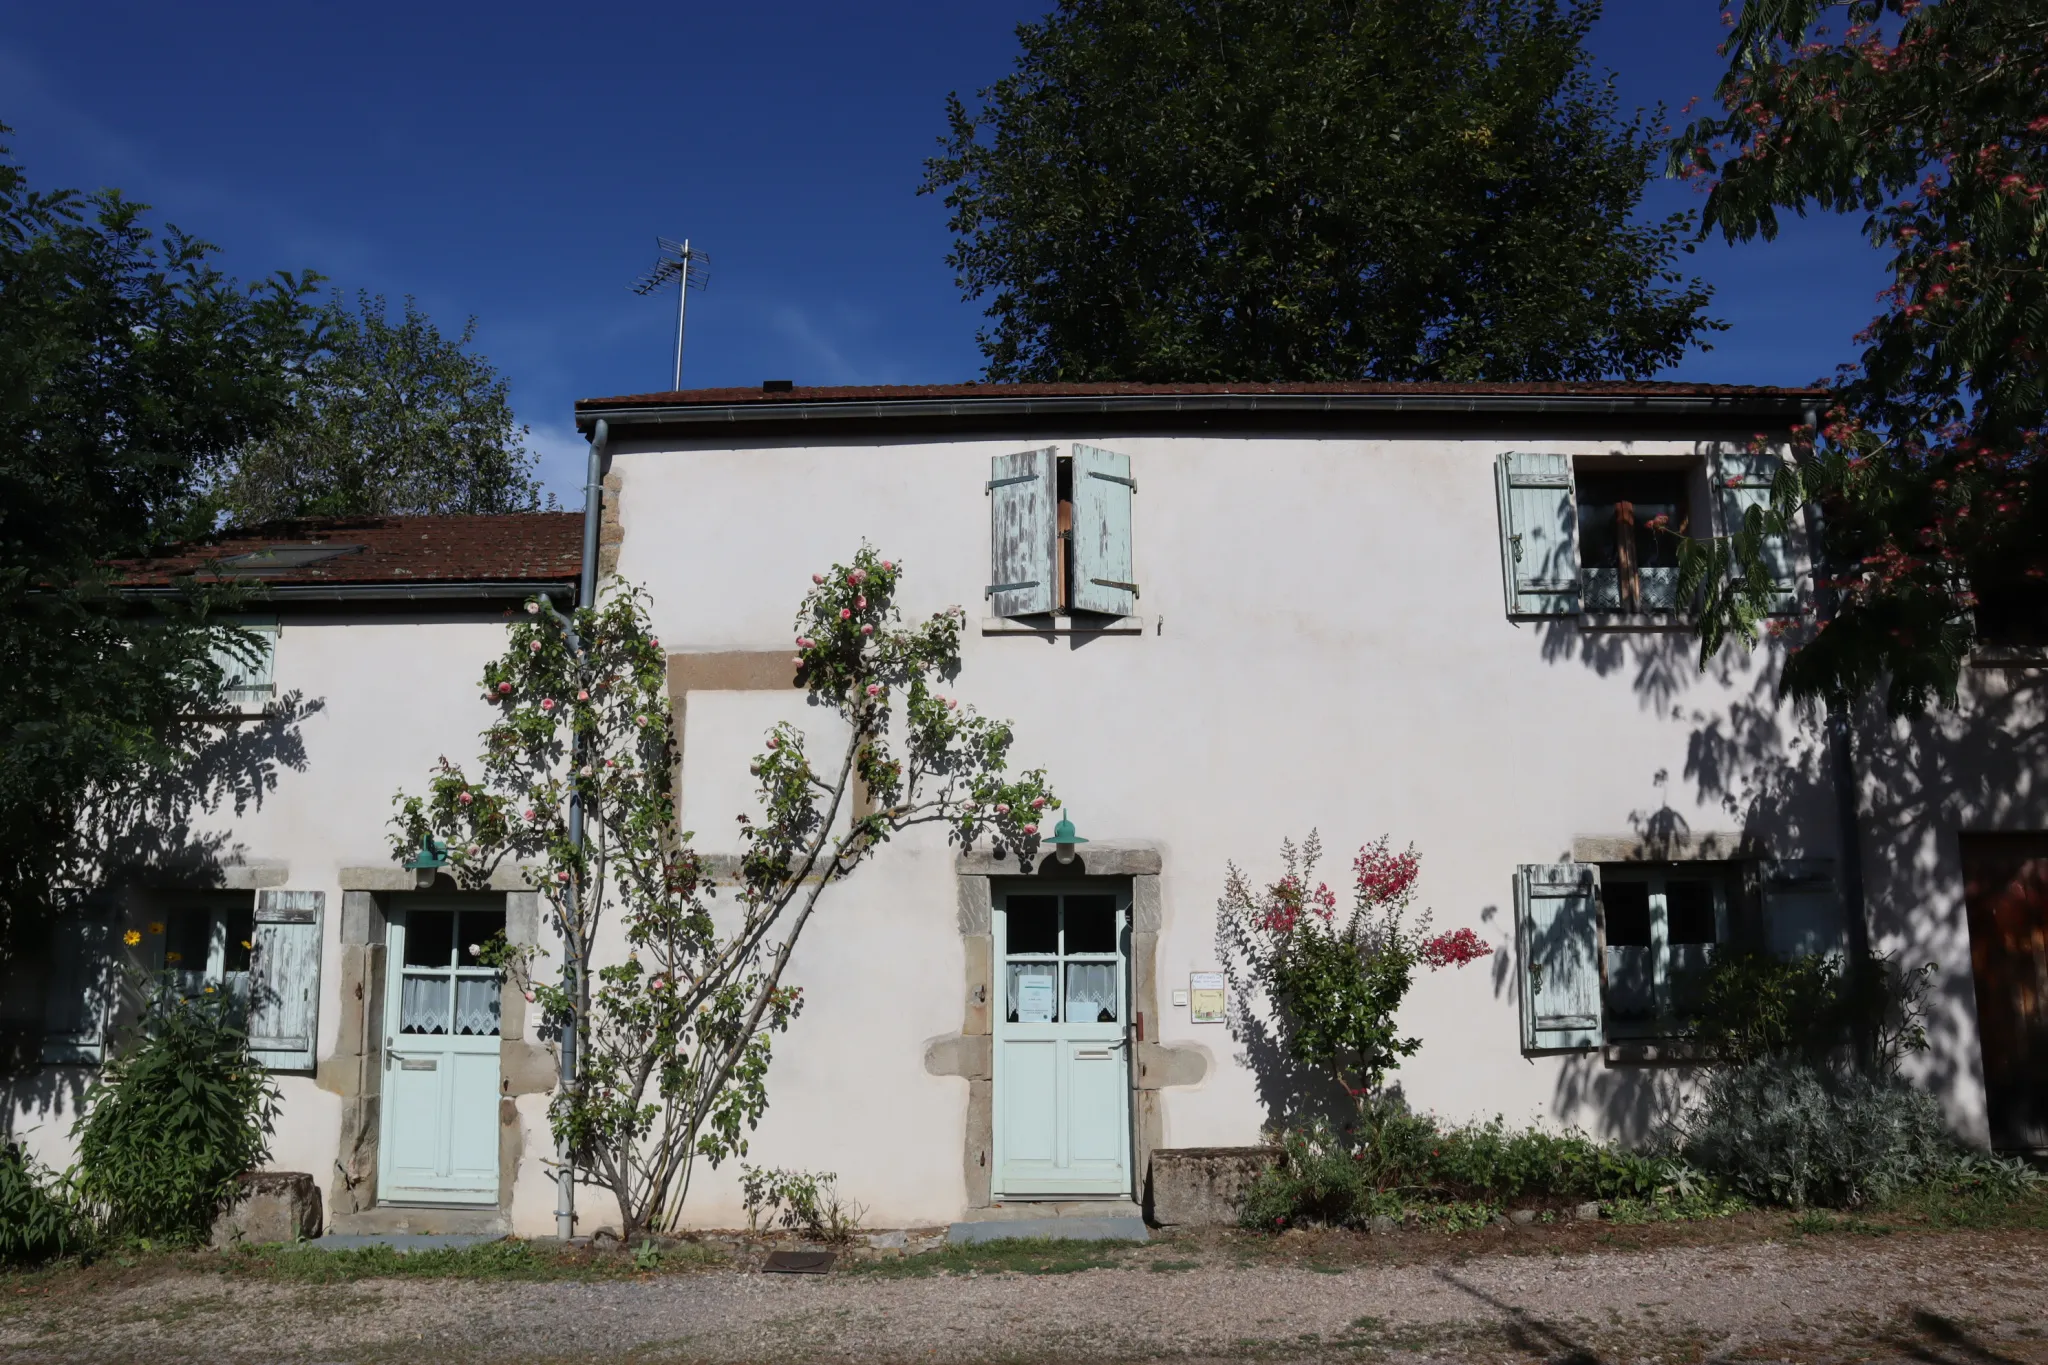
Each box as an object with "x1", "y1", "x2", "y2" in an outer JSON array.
[{"x1": 219, "y1": 293, "x2": 541, "y2": 524}]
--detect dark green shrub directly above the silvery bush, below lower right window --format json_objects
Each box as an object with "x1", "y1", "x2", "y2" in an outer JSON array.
[{"x1": 1692, "y1": 954, "x2": 1933, "y2": 1074}]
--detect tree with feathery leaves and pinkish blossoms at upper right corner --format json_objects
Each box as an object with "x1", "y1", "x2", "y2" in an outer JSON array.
[{"x1": 1671, "y1": 0, "x2": 2048, "y2": 712}]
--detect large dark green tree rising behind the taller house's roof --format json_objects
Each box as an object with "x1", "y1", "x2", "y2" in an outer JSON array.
[{"x1": 924, "y1": 0, "x2": 1720, "y2": 381}]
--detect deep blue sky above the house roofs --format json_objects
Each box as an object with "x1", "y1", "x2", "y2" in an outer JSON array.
[{"x1": 0, "y1": 0, "x2": 1884, "y2": 503}]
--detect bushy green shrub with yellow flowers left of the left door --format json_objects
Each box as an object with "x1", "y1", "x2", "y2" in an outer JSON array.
[{"x1": 72, "y1": 990, "x2": 276, "y2": 1242}]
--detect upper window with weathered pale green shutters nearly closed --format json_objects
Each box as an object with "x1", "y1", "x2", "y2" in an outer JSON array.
[{"x1": 983, "y1": 444, "x2": 1139, "y2": 616}]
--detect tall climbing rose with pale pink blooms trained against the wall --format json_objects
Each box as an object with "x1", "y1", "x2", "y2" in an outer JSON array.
[{"x1": 391, "y1": 546, "x2": 1059, "y2": 1238}]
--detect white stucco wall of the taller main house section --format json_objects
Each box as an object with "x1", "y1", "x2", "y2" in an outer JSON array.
[{"x1": 612, "y1": 430, "x2": 1859, "y2": 1222}]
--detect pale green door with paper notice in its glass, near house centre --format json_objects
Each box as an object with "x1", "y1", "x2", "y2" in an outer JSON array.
[{"x1": 993, "y1": 888, "x2": 1130, "y2": 1197}]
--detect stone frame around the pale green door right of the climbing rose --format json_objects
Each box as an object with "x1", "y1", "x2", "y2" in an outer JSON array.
[{"x1": 924, "y1": 839, "x2": 1208, "y2": 1209}]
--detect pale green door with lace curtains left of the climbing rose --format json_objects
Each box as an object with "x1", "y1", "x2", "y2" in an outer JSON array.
[{"x1": 377, "y1": 900, "x2": 506, "y2": 1203}]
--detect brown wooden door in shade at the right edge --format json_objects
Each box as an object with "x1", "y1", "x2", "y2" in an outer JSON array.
[{"x1": 1962, "y1": 833, "x2": 2048, "y2": 1150}]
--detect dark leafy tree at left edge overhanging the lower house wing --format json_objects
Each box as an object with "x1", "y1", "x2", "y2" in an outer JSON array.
[{"x1": 0, "y1": 129, "x2": 313, "y2": 952}]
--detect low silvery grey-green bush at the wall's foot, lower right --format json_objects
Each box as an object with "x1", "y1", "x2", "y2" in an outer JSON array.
[{"x1": 1677, "y1": 1058, "x2": 1964, "y2": 1207}]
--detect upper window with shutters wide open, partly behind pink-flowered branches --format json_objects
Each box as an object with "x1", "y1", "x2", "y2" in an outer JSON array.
[{"x1": 1495, "y1": 452, "x2": 1798, "y2": 616}]
